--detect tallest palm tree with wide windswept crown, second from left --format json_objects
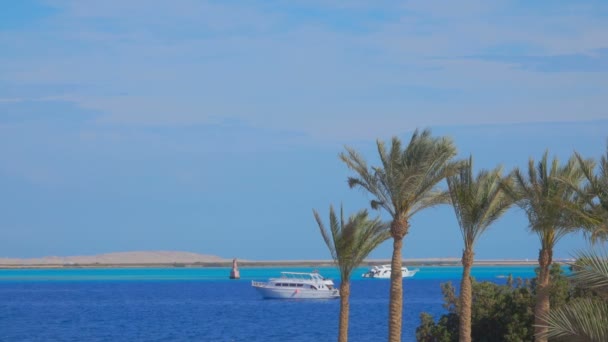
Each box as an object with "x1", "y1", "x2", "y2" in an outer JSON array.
[{"x1": 340, "y1": 130, "x2": 457, "y2": 342}]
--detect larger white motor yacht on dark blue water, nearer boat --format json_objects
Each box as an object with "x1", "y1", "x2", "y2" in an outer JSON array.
[{"x1": 251, "y1": 272, "x2": 340, "y2": 299}]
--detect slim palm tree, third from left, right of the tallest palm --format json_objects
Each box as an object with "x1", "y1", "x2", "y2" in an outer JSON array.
[{"x1": 447, "y1": 157, "x2": 512, "y2": 342}]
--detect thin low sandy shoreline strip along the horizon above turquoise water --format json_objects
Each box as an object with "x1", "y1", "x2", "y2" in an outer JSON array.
[{"x1": 0, "y1": 258, "x2": 572, "y2": 269}]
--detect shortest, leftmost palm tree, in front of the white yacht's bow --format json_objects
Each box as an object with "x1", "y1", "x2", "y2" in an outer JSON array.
[{"x1": 313, "y1": 206, "x2": 390, "y2": 342}]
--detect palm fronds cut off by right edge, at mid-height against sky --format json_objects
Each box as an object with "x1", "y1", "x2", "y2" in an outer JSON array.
[{"x1": 575, "y1": 145, "x2": 608, "y2": 242}]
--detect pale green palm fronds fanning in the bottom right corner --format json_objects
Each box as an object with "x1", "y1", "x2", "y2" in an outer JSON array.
[{"x1": 543, "y1": 248, "x2": 608, "y2": 342}]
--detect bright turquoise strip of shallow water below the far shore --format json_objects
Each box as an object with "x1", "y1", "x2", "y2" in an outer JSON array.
[{"x1": 0, "y1": 266, "x2": 534, "y2": 281}]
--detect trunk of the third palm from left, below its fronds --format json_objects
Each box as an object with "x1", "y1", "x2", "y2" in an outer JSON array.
[{"x1": 459, "y1": 247, "x2": 474, "y2": 342}]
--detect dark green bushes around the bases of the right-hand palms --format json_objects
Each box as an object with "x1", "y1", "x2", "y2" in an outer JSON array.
[{"x1": 416, "y1": 264, "x2": 575, "y2": 342}]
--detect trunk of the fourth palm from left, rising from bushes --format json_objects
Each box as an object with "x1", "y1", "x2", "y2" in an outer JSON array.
[{"x1": 534, "y1": 247, "x2": 553, "y2": 342}]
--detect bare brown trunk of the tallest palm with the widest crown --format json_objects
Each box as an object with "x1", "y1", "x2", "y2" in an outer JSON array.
[{"x1": 388, "y1": 237, "x2": 403, "y2": 342}]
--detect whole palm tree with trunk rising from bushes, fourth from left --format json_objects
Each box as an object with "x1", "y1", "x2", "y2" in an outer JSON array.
[{"x1": 504, "y1": 152, "x2": 585, "y2": 342}]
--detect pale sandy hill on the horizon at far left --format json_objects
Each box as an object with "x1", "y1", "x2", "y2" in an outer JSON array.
[{"x1": 0, "y1": 251, "x2": 231, "y2": 265}]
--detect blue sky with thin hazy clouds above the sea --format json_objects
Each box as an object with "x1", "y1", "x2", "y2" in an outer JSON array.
[{"x1": 0, "y1": 0, "x2": 608, "y2": 259}]
